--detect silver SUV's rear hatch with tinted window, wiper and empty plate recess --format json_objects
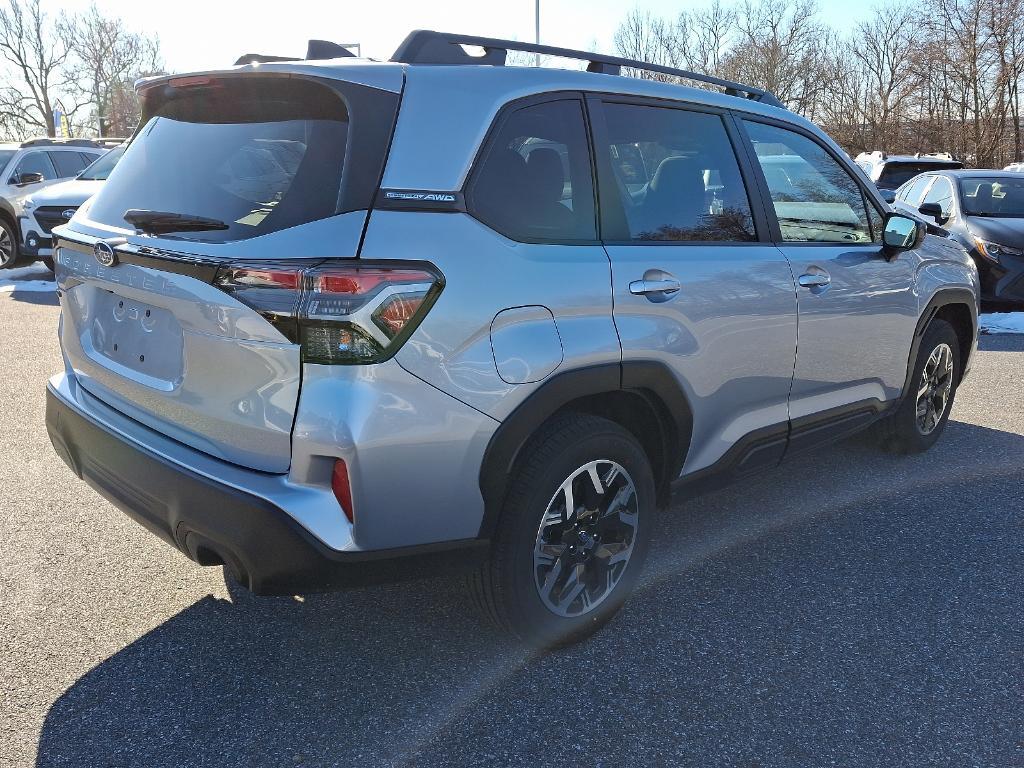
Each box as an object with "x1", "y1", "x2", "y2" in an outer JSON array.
[{"x1": 56, "y1": 68, "x2": 401, "y2": 472}]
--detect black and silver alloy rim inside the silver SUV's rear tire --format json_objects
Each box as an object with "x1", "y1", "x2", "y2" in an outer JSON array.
[{"x1": 534, "y1": 459, "x2": 639, "y2": 617}]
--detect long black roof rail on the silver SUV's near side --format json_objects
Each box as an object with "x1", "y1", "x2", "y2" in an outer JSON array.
[{"x1": 391, "y1": 30, "x2": 785, "y2": 109}]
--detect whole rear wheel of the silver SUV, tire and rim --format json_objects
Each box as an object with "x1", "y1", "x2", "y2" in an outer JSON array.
[{"x1": 469, "y1": 414, "x2": 655, "y2": 648}]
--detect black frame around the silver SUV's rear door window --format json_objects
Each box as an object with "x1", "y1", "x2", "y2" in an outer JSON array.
[{"x1": 586, "y1": 92, "x2": 772, "y2": 248}]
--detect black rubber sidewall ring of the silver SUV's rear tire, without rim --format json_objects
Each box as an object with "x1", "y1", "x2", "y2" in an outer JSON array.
[{"x1": 503, "y1": 420, "x2": 655, "y2": 646}]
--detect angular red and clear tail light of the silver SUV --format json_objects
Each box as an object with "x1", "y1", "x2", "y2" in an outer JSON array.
[{"x1": 214, "y1": 262, "x2": 444, "y2": 365}]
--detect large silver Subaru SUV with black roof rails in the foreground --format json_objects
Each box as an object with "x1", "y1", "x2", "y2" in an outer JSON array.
[{"x1": 47, "y1": 32, "x2": 978, "y2": 645}]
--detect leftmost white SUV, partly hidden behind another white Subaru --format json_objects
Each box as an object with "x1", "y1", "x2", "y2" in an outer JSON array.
[{"x1": 0, "y1": 138, "x2": 106, "y2": 269}]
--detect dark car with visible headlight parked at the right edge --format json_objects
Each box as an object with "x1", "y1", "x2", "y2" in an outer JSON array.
[{"x1": 895, "y1": 170, "x2": 1024, "y2": 304}]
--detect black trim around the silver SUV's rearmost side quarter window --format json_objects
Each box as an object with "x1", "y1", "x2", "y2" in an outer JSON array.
[{"x1": 459, "y1": 91, "x2": 601, "y2": 246}]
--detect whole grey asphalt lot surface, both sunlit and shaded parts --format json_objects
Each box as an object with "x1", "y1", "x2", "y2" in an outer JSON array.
[{"x1": 0, "y1": 276, "x2": 1024, "y2": 768}]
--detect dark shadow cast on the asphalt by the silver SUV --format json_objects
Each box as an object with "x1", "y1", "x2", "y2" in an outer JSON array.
[{"x1": 37, "y1": 422, "x2": 1024, "y2": 768}]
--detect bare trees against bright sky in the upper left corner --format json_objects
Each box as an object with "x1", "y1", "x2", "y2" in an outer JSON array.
[{"x1": 0, "y1": 0, "x2": 164, "y2": 139}]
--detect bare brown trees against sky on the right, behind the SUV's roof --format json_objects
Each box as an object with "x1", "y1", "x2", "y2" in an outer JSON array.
[{"x1": 614, "y1": 0, "x2": 1024, "y2": 168}]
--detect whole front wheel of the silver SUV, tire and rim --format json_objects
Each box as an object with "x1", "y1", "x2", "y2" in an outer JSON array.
[{"x1": 873, "y1": 318, "x2": 962, "y2": 454}]
